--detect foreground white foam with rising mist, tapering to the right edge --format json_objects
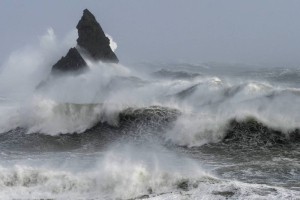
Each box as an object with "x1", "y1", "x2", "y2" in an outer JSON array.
[{"x1": 0, "y1": 144, "x2": 299, "y2": 199}]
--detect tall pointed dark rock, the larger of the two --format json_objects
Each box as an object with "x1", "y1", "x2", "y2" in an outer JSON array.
[{"x1": 76, "y1": 9, "x2": 119, "y2": 63}]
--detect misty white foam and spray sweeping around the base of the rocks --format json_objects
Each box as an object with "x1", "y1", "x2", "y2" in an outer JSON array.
[{"x1": 0, "y1": 29, "x2": 300, "y2": 146}]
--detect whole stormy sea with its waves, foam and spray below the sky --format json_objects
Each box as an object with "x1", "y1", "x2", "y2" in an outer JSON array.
[{"x1": 0, "y1": 30, "x2": 300, "y2": 200}]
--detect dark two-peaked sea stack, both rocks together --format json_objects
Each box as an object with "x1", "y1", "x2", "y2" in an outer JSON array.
[{"x1": 52, "y1": 9, "x2": 119, "y2": 72}]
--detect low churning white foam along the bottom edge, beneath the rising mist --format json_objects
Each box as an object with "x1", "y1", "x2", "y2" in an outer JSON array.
[{"x1": 0, "y1": 165, "x2": 299, "y2": 199}]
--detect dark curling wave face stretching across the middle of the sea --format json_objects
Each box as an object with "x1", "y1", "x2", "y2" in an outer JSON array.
[{"x1": 0, "y1": 104, "x2": 300, "y2": 151}]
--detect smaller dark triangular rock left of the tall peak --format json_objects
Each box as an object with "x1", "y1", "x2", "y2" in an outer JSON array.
[{"x1": 52, "y1": 48, "x2": 87, "y2": 72}]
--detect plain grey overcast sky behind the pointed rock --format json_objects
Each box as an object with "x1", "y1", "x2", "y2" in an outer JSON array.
[{"x1": 0, "y1": 0, "x2": 300, "y2": 66}]
